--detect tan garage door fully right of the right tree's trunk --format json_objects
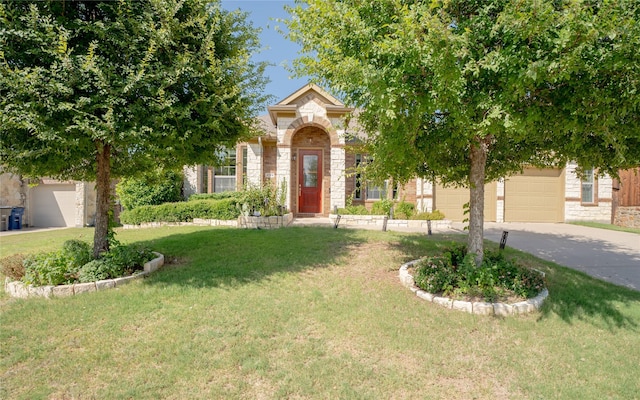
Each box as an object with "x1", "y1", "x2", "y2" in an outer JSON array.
[{"x1": 504, "y1": 168, "x2": 564, "y2": 222}]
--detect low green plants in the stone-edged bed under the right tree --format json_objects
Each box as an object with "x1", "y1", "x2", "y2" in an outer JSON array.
[{"x1": 414, "y1": 245, "x2": 545, "y2": 302}]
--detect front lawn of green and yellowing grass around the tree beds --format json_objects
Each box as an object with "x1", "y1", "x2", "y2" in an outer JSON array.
[{"x1": 0, "y1": 227, "x2": 640, "y2": 399}]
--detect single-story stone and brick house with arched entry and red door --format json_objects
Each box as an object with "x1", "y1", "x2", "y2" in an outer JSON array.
[{"x1": 185, "y1": 84, "x2": 624, "y2": 222}]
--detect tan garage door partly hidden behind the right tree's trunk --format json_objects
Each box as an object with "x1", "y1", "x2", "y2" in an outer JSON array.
[{"x1": 434, "y1": 182, "x2": 497, "y2": 221}]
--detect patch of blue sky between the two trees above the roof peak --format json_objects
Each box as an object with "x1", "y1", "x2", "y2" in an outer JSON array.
[{"x1": 221, "y1": 0, "x2": 308, "y2": 113}]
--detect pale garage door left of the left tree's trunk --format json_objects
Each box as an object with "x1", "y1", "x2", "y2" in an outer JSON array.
[{"x1": 30, "y1": 184, "x2": 76, "y2": 228}]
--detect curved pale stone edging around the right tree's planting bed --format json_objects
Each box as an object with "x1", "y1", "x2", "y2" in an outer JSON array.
[{"x1": 399, "y1": 260, "x2": 549, "y2": 317}]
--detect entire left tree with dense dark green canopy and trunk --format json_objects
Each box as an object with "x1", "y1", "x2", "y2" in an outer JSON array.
[{"x1": 0, "y1": 0, "x2": 266, "y2": 257}]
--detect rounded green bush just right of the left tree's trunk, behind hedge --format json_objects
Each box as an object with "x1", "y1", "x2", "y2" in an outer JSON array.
[{"x1": 116, "y1": 170, "x2": 184, "y2": 210}]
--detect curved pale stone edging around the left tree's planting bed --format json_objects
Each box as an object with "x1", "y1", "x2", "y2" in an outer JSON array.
[{"x1": 4, "y1": 251, "x2": 164, "y2": 299}]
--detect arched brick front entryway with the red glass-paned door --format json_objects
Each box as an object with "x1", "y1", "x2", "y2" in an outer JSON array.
[{"x1": 290, "y1": 125, "x2": 331, "y2": 216}]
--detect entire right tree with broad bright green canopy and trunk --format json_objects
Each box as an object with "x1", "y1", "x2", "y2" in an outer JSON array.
[{"x1": 287, "y1": 0, "x2": 640, "y2": 264}]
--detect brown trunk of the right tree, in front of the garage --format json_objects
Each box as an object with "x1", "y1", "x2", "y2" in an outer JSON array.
[{"x1": 467, "y1": 140, "x2": 488, "y2": 267}]
